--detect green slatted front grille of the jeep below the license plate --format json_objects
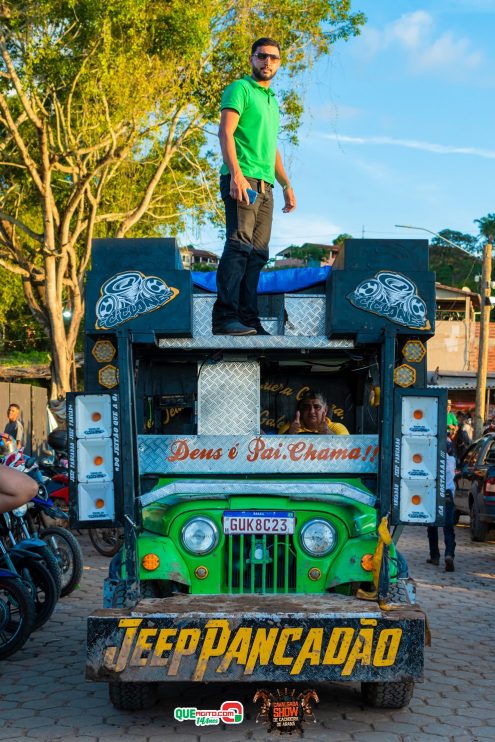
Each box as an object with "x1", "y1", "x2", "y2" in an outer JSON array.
[{"x1": 225, "y1": 534, "x2": 296, "y2": 593}]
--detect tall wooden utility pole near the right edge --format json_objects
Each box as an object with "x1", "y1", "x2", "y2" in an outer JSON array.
[{"x1": 474, "y1": 235, "x2": 492, "y2": 440}]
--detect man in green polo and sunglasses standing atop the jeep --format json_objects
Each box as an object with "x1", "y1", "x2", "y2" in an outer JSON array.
[{"x1": 212, "y1": 37, "x2": 296, "y2": 335}]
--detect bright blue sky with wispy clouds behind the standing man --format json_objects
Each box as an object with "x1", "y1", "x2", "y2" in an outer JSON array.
[{"x1": 180, "y1": 0, "x2": 495, "y2": 255}]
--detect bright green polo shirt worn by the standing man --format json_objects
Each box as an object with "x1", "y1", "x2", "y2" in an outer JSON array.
[{"x1": 220, "y1": 75, "x2": 280, "y2": 185}]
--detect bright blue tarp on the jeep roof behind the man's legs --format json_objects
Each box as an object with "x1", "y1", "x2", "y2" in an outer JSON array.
[{"x1": 192, "y1": 266, "x2": 331, "y2": 294}]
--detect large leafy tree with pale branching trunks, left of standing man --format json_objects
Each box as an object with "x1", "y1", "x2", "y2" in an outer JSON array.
[{"x1": 0, "y1": 0, "x2": 365, "y2": 396}]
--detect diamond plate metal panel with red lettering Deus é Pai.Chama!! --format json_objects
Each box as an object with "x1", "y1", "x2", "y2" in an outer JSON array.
[{"x1": 138, "y1": 436, "x2": 378, "y2": 476}]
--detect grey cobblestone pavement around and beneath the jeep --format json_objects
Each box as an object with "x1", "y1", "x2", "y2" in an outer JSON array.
[{"x1": 0, "y1": 523, "x2": 495, "y2": 742}]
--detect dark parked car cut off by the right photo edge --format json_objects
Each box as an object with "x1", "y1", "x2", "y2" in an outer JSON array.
[{"x1": 454, "y1": 433, "x2": 495, "y2": 541}]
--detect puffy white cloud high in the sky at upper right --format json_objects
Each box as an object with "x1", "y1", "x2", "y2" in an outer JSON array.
[{"x1": 363, "y1": 10, "x2": 483, "y2": 75}]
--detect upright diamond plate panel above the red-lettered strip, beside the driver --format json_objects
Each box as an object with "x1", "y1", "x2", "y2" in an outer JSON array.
[{"x1": 198, "y1": 361, "x2": 260, "y2": 435}]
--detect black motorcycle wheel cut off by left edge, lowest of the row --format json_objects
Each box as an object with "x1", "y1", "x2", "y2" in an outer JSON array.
[{"x1": 0, "y1": 577, "x2": 35, "y2": 660}]
